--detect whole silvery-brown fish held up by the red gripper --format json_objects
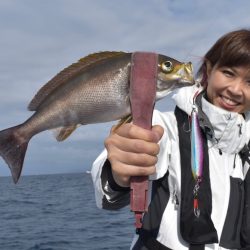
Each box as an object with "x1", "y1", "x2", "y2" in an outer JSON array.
[{"x1": 0, "y1": 51, "x2": 194, "y2": 183}]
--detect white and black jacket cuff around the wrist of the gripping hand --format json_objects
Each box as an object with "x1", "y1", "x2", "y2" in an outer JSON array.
[{"x1": 91, "y1": 150, "x2": 130, "y2": 210}]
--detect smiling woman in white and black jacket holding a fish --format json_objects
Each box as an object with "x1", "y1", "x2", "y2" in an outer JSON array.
[{"x1": 92, "y1": 30, "x2": 250, "y2": 250}]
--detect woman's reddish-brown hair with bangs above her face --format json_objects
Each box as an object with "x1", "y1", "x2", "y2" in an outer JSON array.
[{"x1": 197, "y1": 29, "x2": 250, "y2": 86}]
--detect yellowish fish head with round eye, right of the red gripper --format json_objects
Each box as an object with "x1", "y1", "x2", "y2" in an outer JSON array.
[{"x1": 156, "y1": 55, "x2": 195, "y2": 100}]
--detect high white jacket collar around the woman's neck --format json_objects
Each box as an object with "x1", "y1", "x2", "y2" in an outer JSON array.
[{"x1": 173, "y1": 86, "x2": 250, "y2": 153}]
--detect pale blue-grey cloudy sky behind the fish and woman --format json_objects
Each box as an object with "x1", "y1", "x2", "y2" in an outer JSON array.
[{"x1": 0, "y1": 0, "x2": 250, "y2": 179}]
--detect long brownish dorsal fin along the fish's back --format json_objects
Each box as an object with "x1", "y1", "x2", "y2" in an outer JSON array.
[{"x1": 28, "y1": 51, "x2": 125, "y2": 111}]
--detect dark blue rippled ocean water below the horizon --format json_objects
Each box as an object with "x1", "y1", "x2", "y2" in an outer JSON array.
[{"x1": 0, "y1": 173, "x2": 134, "y2": 250}]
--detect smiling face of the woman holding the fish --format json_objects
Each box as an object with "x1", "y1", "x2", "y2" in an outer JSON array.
[{"x1": 207, "y1": 63, "x2": 250, "y2": 113}]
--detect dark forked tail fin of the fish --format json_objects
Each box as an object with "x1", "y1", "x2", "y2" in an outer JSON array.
[{"x1": 0, "y1": 126, "x2": 29, "y2": 183}]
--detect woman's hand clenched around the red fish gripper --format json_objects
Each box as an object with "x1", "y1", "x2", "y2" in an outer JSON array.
[{"x1": 105, "y1": 123, "x2": 164, "y2": 187}]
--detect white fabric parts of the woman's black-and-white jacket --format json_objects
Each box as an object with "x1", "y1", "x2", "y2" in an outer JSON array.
[{"x1": 92, "y1": 86, "x2": 250, "y2": 250}]
